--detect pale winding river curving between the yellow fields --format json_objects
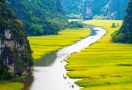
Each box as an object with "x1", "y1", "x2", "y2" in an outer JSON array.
[{"x1": 23, "y1": 25, "x2": 106, "y2": 90}]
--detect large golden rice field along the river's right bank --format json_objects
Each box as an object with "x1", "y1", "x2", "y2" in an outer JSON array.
[{"x1": 66, "y1": 20, "x2": 132, "y2": 90}]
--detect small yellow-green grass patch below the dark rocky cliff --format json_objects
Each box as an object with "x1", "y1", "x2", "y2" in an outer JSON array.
[{"x1": 0, "y1": 82, "x2": 23, "y2": 90}]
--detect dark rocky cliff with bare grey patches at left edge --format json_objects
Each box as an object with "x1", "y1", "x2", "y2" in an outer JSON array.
[{"x1": 0, "y1": 0, "x2": 33, "y2": 79}]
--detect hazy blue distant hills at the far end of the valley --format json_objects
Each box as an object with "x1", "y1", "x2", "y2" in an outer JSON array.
[{"x1": 61, "y1": 0, "x2": 129, "y2": 19}]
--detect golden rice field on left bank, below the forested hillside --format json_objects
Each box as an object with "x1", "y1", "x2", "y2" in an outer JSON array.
[{"x1": 28, "y1": 28, "x2": 90, "y2": 60}]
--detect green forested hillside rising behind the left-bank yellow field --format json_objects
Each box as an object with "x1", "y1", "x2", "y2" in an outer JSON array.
[{"x1": 8, "y1": 0, "x2": 68, "y2": 35}]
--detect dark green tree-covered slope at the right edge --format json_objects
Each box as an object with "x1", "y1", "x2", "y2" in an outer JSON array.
[{"x1": 112, "y1": 0, "x2": 132, "y2": 43}]
